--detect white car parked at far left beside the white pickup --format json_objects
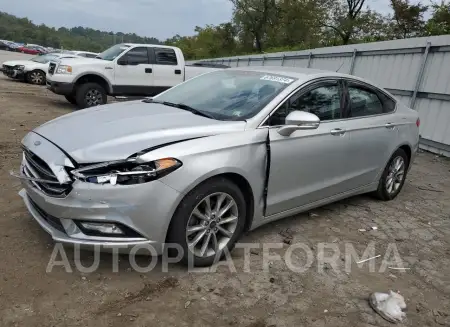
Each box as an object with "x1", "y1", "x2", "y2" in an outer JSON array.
[{"x1": 2, "y1": 53, "x2": 82, "y2": 85}]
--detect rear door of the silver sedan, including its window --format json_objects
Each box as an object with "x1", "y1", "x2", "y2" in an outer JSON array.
[{"x1": 344, "y1": 80, "x2": 398, "y2": 188}]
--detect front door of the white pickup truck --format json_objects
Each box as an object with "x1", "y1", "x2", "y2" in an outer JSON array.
[{"x1": 113, "y1": 47, "x2": 154, "y2": 95}]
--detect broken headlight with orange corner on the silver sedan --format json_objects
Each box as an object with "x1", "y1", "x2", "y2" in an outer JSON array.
[{"x1": 71, "y1": 158, "x2": 182, "y2": 185}]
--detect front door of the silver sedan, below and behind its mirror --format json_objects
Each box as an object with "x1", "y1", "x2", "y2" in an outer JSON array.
[{"x1": 266, "y1": 80, "x2": 349, "y2": 216}]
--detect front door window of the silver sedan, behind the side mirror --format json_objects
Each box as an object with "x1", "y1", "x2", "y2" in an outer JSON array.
[{"x1": 269, "y1": 82, "x2": 341, "y2": 126}]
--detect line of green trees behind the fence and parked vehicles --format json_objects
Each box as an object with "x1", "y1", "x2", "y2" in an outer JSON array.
[{"x1": 0, "y1": 0, "x2": 450, "y2": 59}]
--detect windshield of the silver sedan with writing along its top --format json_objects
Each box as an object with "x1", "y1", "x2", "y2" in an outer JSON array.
[{"x1": 153, "y1": 69, "x2": 295, "y2": 120}]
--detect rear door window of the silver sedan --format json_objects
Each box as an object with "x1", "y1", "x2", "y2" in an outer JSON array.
[{"x1": 348, "y1": 85, "x2": 384, "y2": 117}]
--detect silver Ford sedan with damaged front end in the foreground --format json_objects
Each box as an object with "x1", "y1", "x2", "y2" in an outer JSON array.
[{"x1": 10, "y1": 67, "x2": 420, "y2": 265}]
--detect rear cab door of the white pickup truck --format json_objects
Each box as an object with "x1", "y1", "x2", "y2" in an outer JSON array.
[{"x1": 152, "y1": 47, "x2": 184, "y2": 92}]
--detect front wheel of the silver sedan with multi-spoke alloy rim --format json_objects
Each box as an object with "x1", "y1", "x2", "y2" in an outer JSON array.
[{"x1": 167, "y1": 177, "x2": 247, "y2": 267}]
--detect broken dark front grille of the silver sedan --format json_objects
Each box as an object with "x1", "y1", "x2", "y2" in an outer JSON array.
[{"x1": 23, "y1": 148, "x2": 71, "y2": 197}]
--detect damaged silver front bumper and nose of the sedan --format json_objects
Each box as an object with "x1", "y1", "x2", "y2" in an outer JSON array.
[{"x1": 12, "y1": 133, "x2": 182, "y2": 254}]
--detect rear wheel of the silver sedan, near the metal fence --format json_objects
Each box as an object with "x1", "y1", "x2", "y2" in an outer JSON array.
[{"x1": 375, "y1": 149, "x2": 409, "y2": 201}]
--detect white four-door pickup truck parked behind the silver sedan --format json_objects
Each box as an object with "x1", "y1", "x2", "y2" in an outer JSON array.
[{"x1": 46, "y1": 43, "x2": 228, "y2": 108}]
